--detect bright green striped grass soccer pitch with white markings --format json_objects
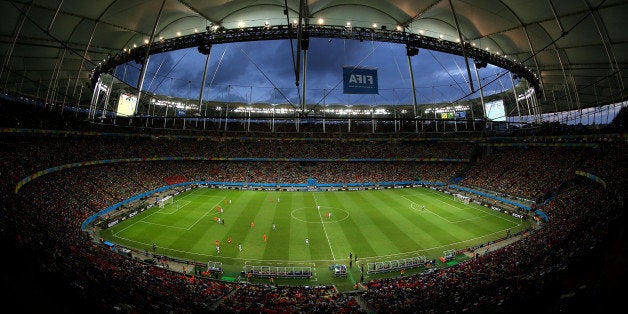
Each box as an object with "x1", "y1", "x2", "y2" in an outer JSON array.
[{"x1": 101, "y1": 188, "x2": 529, "y2": 290}]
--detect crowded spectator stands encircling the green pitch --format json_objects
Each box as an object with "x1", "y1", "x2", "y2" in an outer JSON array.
[{"x1": 0, "y1": 98, "x2": 626, "y2": 313}]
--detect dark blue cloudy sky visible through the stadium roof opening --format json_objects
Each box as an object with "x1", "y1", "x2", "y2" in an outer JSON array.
[{"x1": 117, "y1": 38, "x2": 512, "y2": 105}]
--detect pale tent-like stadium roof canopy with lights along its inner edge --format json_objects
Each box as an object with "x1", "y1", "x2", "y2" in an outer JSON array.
[{"x1": 0, "y1": 0, "x2": 628, "y2": 112}]
